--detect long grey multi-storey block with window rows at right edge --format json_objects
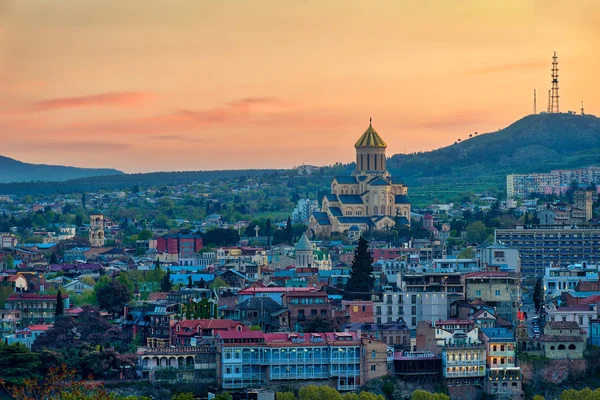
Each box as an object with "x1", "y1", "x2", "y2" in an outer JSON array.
[{"x1": 495, "y1": 228, "x2": 600, "y2": 278}]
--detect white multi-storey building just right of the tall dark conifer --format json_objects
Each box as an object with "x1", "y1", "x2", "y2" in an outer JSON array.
[{"x1": 373, "y1": 291, "x2": 451, "y2": 329}]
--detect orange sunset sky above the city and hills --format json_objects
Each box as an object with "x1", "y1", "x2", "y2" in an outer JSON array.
[{"x1": 0, "y1": 0, "x2": 600, "y2": 172}]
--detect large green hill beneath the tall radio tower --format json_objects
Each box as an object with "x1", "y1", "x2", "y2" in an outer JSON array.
[{"x1": 388, "y1": 114, "x2": 600, "y2": 198}]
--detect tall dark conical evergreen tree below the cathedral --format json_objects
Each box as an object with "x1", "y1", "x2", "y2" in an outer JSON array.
[{"x1": 344, "y1": 236, "x2": 375, "y2": 300}]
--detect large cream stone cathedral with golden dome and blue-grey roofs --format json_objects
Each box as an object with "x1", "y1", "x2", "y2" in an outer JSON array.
[{"x1": 309, "y1": 123, "x2": 410, "y2": 235}]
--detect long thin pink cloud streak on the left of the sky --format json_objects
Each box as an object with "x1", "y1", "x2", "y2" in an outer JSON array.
[{"x1": 28, "y1": 92, "x2": 152, "y2": 111}]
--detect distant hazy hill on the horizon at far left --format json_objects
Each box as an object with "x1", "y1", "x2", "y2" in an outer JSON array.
[{"x1": 0, "y1": 156, "x2": 123, "y2": 183}]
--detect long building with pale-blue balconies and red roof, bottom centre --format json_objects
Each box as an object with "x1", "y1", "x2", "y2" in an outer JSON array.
[{"x1": 216, "y1": 331, "x2": 366, "y2": 391}]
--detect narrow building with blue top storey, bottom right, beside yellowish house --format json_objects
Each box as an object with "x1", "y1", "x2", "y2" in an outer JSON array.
[{"x1": 480, "y1": 328, "x2": 523, "y2": 399}]
